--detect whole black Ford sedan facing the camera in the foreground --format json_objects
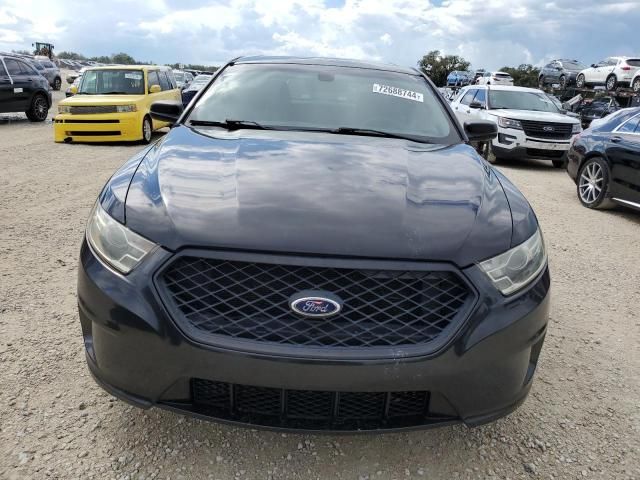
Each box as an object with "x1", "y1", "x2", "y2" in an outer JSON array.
[{"x1": 78, "y1": 57, "x2": 550, "y2": 430}]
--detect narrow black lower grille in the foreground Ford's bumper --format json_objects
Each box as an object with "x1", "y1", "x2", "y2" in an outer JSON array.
[{"x1": 191, "y1": 378, "x2": 442, "y2": 430}]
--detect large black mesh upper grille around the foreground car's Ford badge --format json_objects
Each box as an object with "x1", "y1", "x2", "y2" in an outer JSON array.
[{"x1": 159, "y1": 256, "x2": 475, "y2": 348}]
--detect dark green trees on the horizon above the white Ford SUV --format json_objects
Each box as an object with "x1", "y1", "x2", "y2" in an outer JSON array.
[{"x1": 418, "y1": 50, "x2": 540, "y2": 87}]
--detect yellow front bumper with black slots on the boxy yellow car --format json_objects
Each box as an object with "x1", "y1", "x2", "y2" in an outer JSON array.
[{"x1": 53, "y1": 112, "x2": 144, "y2": 142}]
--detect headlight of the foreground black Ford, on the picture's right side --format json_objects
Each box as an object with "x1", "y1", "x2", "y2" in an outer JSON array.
[{"x1": 480, "y1": 229, "x2": 547, "y2": 295}]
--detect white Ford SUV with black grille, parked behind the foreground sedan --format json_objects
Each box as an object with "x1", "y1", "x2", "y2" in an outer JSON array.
[{"x1": 451, "y1": 85, "x2": 582, "y2": 168}]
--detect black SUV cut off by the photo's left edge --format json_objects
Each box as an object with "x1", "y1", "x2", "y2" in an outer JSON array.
[{"x1": 0, "y1": 54, "x2": 51, "y2": 122}]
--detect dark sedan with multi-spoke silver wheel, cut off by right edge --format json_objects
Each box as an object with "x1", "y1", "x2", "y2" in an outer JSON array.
[{"x1": 567, "y1": 108, "x2": 640, "y2": 210}]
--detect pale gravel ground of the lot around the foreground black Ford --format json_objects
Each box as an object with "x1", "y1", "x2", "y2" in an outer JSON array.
[{"x1": 0, "y1": 92, "x2": 640, "y2": 480}]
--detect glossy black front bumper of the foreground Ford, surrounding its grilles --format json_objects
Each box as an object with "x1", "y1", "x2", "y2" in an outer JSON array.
[{"x1": 78, "y1": 242, "x2": 550, "y2": 431}]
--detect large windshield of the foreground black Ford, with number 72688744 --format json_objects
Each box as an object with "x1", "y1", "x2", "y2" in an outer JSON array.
[{"x1": 188, "y1": 64, "x2": 460, "y2": 143}]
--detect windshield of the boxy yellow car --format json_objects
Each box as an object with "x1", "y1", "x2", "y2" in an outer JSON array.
[{"x1": 78, "y1": 69, "x2": 144, "y2": 95}]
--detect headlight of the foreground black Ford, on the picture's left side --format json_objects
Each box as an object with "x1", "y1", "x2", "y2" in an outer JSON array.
[{"x1": 87, "y1": 202, "x2": 156, "y2": 274}]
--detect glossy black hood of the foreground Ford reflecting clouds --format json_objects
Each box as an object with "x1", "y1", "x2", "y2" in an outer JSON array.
[{"x1": 124, "y1": 126, "x2": 512, "y2": 266}]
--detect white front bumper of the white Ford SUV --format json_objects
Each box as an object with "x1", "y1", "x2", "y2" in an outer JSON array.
[{"x1": 492, "y1": 127, "x2": 577, "y2": 160}]
